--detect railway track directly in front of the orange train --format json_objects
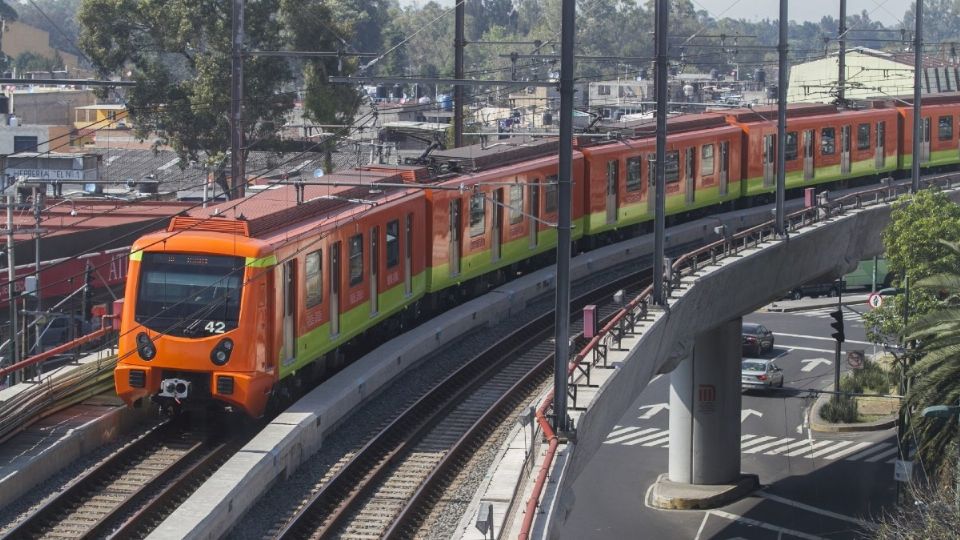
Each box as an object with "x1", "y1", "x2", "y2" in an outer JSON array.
[{"x1": 5, "y1": 419, "x2": 246, "y2": 539}]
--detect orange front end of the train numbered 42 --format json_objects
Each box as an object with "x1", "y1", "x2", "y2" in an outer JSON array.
[{"x1": 114, "y1": 228, "x2": 277, "y2": 417}]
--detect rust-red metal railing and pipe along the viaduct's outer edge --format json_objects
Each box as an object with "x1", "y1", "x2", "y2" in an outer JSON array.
[{"x1": 518, "y1": 174, "x2": 957, "y2": 540}]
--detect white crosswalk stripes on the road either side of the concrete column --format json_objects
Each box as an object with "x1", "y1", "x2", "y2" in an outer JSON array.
[{"x1": 604, "y1": 426, "x2": 897, "y2": 463}]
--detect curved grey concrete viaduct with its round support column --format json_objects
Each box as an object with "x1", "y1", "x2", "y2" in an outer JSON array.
[{"x1": 547, "y1": 184, "x2": 960, "y2": 536}]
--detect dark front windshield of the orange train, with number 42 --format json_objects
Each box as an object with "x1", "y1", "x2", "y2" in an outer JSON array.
[{"x1": 136, "y1": 253, "x2": 244, "y2": 337}]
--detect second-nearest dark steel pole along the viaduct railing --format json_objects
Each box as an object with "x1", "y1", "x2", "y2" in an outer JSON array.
[{"x1": 647, "y1": 0, "x2": 670, "y2": 306}]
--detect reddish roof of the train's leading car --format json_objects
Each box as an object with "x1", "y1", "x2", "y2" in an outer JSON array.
[{"x1": 167, "y1": 168, "x2": 418, "y2": 238}]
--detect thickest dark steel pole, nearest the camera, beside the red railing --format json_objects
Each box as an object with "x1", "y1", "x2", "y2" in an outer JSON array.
[{"x1": 553, "y1": 0, "x2": 577, "y2": 433}]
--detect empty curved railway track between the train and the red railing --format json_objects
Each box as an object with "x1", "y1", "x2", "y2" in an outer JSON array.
[{"x1": 269, "y1": 268, "x2": 640, "y2": 539}]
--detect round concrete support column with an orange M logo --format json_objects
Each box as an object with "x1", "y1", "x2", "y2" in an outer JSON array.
[{"x1": 668, "y1": 318, "x2": 742, "y2": 485}]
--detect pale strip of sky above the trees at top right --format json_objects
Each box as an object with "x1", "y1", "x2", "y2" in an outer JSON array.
[{"x1": 691, "y1": 0, "x2": 911, "y2": 27}]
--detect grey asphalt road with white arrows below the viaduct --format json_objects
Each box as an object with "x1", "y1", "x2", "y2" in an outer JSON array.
[{"x1": 558, "y1": 306, "x2": 897, "y2": 540}]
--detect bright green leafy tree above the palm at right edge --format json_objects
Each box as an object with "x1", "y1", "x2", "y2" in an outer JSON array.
[{"x1": 864, "y1": 188, "x2": 960, "y2": 343}]
